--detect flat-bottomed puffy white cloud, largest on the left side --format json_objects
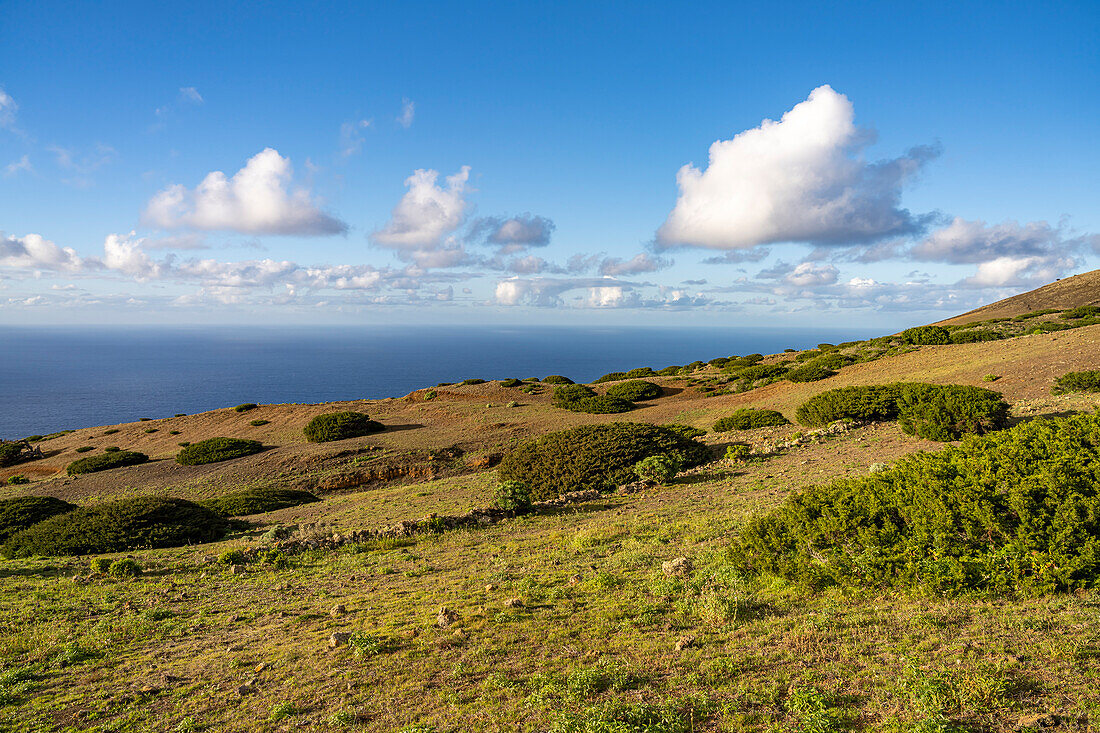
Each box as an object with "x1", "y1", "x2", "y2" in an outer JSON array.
[{"x1": 144, "y1": 147, "x2": 348, "y2": 234}]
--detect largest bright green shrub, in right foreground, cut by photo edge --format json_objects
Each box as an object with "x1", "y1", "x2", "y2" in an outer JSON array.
[{"x1": 730, "y1": 415, "x2": 1100, "y2": 595}]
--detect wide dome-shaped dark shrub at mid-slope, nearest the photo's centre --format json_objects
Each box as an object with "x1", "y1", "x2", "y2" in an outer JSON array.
[{"x1": 498, "y1": 423, "x2": 710, "y2": 501}]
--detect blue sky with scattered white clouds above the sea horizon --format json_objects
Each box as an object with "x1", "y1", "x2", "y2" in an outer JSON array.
[{"x1": 0, "y1": 0, "x2": 1100, "y2": 328}]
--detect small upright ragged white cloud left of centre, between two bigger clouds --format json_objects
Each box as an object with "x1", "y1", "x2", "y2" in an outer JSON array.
[{"x1": 371, "y1": 165, "x2": 470, "y2": 253}]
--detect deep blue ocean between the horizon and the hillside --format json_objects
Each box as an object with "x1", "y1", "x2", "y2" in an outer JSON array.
[{"x1": 0, "y1": 326, "x2": 867, "y2": 439}]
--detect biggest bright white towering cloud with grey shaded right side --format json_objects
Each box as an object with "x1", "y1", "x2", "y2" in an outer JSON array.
[{"x1": 657, "y1": 86, "x2": 936, "y2": 249}]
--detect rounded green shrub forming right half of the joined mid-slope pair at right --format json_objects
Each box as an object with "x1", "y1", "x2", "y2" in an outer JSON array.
[{"x1": 898, "y1": 384, "x2": 1009, "y2": 441}]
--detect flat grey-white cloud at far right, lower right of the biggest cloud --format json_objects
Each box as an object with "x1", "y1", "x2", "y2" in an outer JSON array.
[{"x1": 910, "y1": 217, "x2": 1100, "y2": 264}]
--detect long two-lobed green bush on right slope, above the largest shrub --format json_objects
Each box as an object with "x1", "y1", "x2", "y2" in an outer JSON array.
[{"x1": 795, "y1": 382, "x2": 1009, "y2": 440}]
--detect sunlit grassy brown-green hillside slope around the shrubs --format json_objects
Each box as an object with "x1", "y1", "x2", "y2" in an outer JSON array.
[{"x1": 0, "y1": 327, "x2": 1100, "y2": 731}]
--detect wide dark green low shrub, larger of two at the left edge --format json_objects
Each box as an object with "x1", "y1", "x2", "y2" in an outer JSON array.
[{"x1": 0, "y1": 496, "x2": 229, "y2": 558}]
